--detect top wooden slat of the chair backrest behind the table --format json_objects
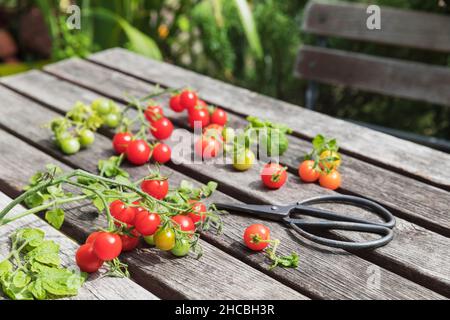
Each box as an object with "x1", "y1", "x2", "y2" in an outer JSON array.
[{"x1": 302, "y1": 1, "x2": 450, "y2": 52}]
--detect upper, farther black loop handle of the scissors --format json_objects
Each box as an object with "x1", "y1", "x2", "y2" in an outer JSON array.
[{"x1": 294, "y1": 195, "x2": 395, "y2": 230}]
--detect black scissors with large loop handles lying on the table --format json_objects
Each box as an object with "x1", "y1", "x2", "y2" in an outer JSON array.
[{"x1": 215, "y1": 195, "x2": 395, "y2": 250}]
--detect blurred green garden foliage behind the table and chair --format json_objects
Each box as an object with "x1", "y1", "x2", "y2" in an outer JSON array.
[{"x1": 0, "y1": 0, "x2": 450, "y2": 139}]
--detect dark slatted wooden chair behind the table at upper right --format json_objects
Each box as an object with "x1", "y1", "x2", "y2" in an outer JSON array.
[{"x1": 295, "y1": 1, "x2": 450, "y2": 152}]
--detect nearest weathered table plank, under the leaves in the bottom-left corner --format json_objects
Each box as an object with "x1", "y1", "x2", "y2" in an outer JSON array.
[{"x1": 0, "y1": 192, "x2": 158, "y2": 300}]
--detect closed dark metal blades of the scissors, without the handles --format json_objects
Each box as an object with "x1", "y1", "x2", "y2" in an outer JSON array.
[{"x1": 215, "y1": 203, "x2": 292, "y2": 221}]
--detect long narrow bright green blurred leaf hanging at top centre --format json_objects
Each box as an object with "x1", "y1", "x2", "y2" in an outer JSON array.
[{"x1": 234, "y1": 0, "x2": 264, "y2": 59}]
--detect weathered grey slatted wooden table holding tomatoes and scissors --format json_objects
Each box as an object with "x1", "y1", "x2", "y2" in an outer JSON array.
[{"x1": 0, "y1": 49, "x2": 450, "y2": 299}]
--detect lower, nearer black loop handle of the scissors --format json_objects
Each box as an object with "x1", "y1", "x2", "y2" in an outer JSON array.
[{"x1": 285, "y1": 218, "x2": 394, "y2": 250}]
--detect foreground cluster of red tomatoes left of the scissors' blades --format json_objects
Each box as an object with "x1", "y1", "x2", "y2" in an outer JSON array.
[{"x1": 76, "y1": 173, "x2": 208, "y2": 273}]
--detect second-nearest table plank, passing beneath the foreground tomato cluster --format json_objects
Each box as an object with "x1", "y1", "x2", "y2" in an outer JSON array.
[{"x1": 0, "y1": 127, "x2": 306, "y2": 299}]
